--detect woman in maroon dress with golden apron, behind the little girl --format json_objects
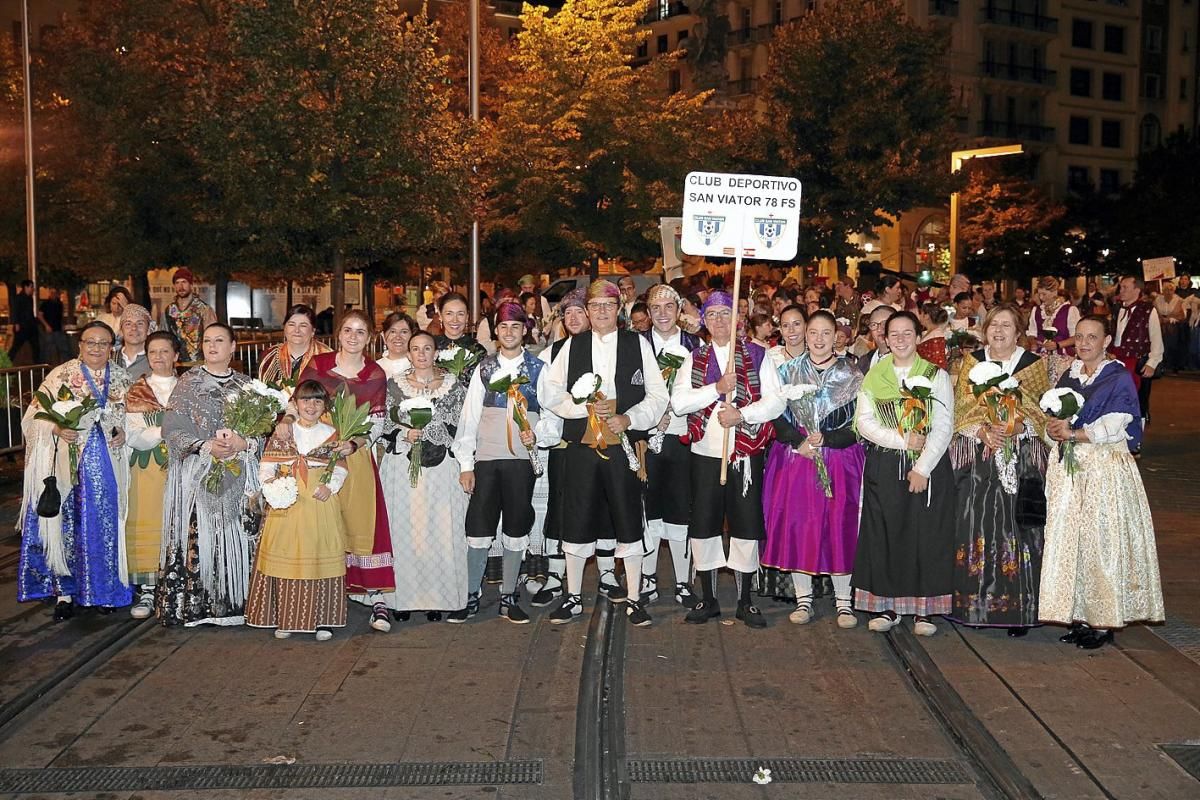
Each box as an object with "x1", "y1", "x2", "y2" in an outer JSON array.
[{"x1": 295, "y1": 308, "x2": 396, "y2": 633}]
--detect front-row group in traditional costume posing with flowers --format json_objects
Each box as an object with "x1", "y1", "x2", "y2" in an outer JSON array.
[{"x1": 18, "y1": 275, "x2": 1164, "y2": 649}]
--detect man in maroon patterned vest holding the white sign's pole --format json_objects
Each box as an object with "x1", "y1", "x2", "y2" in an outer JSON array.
[{"x1": 671, "y1": 291, "x2": 784, "y2": 627}]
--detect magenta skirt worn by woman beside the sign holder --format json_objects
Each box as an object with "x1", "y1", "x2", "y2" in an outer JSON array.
[{"x1": 761, "y1": 444, "x2": 866, "y2": 575}]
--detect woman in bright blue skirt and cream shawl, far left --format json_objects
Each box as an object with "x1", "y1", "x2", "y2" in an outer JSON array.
[{"x1": 17, "y1": 323, "x2": 133, "y2": 621}]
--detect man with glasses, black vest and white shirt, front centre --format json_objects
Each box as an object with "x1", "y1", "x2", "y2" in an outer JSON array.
[{"x1": 542, "y1": 281, "x2": 668, "y2": 626}]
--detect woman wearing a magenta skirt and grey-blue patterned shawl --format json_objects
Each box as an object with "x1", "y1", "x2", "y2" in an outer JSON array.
[{"x1": 762, "y1": 309, "x2": 865, "y2": 627}]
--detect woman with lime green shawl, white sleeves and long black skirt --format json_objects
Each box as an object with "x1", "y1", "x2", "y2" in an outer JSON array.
[{"x1": 852, "y1": 311, "x2": 954, "y2": 636}]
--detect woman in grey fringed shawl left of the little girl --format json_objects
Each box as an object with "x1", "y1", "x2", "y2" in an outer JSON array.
[{"x1": 155, "y1": 323, "x2": 260, "y2": 626}]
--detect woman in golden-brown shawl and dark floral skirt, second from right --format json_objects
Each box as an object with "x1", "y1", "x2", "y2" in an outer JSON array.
[{"x1": 950, "y1": 303, "x2": 1050, "y2": 636}]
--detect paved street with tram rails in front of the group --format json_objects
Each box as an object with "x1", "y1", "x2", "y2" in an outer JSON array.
[{"x1": 0, "y1": 378, "x2": 1200, "y2": 800}]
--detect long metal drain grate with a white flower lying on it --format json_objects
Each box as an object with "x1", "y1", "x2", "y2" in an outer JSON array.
[{"x1": 625, "y1": 758, "x2": 973, "y2": 783}]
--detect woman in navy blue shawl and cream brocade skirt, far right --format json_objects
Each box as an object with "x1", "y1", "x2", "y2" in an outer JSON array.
[{"x1": 1038, "y1": 317, "x2": 1164, "y2": 650}]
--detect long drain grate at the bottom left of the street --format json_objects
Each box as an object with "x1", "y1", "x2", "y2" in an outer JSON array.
[{"x1": 0, "y1": 760, "x2": 542, "y2": 794}]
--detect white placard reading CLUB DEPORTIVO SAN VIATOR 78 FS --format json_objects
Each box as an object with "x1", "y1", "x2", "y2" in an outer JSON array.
[{"x1": 683, "y1": 173, "x2": 800, "y2": 261}]
